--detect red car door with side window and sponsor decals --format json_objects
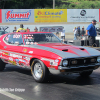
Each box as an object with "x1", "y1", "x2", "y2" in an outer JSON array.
[{"x1": 2, "y1": 33, "x2": 23, "y2": 65}]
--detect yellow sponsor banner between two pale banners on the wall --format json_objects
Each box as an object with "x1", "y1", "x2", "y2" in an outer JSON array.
[{"x1": 34, "y1": 9, "x2": 67, "y2": 23}]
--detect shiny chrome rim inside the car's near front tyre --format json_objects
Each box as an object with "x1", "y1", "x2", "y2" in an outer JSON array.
[{"x1": 34, "y1": 63, "x2": 43, "y2": 78}]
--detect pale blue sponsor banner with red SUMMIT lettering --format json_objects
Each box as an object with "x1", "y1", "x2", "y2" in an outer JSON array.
[{"x1": 2, "y1": 9, "x2": 34, "y2": 23}]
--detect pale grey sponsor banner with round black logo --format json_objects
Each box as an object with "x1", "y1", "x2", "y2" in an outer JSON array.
[{"x1": 67, "y1": 9, "x2": 99, "y2": 22}]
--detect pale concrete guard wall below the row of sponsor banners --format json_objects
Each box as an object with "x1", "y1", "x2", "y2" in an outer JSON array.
[{"x1": 0, "y1": 22, "x2": 100, "y2": 35}]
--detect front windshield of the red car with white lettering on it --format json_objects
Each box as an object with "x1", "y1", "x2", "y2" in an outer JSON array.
[{"x1": 23, "y1": 33, "x2": 61, "y2": 45}]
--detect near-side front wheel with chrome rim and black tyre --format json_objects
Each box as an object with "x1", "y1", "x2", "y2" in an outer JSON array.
[{"x1": 31, "y1": 59, "x2": 49, "y2": 83}]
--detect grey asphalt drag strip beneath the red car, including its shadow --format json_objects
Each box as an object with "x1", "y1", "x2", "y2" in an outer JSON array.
[{"x1": 0, "y1": 65, "x2": 100, "y2": 100}]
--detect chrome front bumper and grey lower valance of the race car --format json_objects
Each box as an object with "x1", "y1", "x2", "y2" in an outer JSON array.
[{"x1": 49, "y1": 63, "x2": 100, "y2": 74}]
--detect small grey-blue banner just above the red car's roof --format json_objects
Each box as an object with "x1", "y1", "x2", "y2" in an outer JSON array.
[{"x1": 40, "y1": 26, "x2": 64, "y2": 32}]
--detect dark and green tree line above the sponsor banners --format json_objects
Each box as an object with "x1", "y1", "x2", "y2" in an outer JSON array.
[{"x1": 0, "y1": 0, "x2": 100, "y2": 9}]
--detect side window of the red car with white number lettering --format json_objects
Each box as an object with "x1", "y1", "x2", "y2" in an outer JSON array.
[{"x1": 5, "y1": 34, "x2": 23, "y2": 45}]
